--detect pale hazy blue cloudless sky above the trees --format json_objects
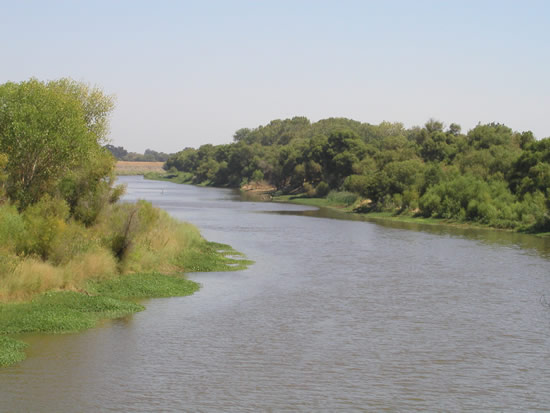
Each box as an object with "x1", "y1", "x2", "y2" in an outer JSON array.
[{"x1": 0, "y1": 0, "x2": 550, "y2": 153}]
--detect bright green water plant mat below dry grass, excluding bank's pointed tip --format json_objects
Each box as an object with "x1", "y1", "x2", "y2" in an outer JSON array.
[{"x1": 0, "y1": 274, "x2": 199, "y2": 366}]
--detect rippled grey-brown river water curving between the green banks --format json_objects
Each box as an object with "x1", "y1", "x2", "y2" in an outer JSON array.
[{"x1": 0, "y1": 177, "x2": 550, "y2": 412}]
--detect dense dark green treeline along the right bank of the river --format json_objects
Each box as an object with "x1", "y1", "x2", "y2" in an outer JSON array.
[{"x1": 165, "y1": 117, "x2": 550, "y2": 231}]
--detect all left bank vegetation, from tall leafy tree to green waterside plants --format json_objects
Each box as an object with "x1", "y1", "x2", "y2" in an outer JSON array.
[{"x1": 0, "y1": 79, "x2": 250, "y2": 366}]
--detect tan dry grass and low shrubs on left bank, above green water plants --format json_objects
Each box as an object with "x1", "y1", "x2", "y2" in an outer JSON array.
[{"x1": 0, "y1": 201, "x2": 249, "y2": 300}]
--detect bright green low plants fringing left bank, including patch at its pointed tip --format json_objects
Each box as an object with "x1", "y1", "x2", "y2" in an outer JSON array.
[{"x1": 0, "y1": 241, "x2": 251, "y2": 366}]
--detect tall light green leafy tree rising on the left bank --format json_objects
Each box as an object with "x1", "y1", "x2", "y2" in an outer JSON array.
[{"x1": 0, "y1": 79, "x2": 113, "y2": 209}]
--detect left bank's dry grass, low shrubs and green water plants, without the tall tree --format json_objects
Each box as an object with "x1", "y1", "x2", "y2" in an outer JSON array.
[{"x1": 0, "y1": 201, "x2": 251, "y2": 366}]
